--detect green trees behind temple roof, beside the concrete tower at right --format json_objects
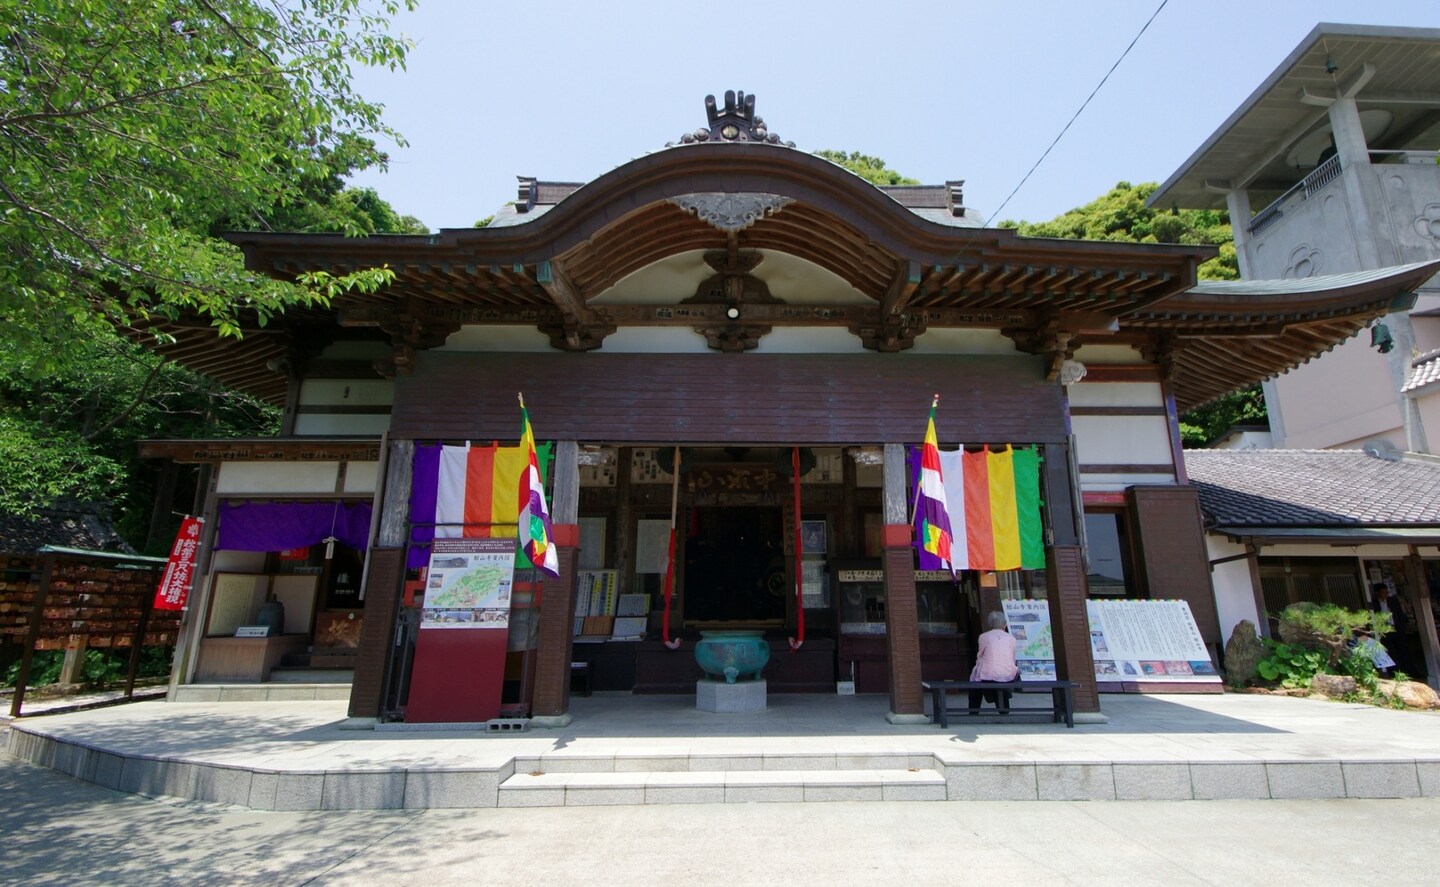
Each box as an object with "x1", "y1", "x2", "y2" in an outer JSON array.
[{"x1": 998, "y1": 181, "x2": 1266, "y2": 446}]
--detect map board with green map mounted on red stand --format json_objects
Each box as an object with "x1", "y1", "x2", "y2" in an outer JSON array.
[{"x1": 420, "y1": 539, "x2": 516, "y2": 629}]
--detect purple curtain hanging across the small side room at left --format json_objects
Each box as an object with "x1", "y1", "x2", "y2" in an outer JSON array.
[{"x1": 215, "y1": 501, "x2": 370, "y2": 551}]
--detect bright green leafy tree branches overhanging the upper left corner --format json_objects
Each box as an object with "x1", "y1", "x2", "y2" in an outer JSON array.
[{"x1": 0, "y1": 0, "x2": 413, "y2": 374}]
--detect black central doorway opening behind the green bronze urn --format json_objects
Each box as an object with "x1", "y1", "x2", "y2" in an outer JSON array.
[{"x1": 685, "y1": 507, "x2": 786, "y2": 628}]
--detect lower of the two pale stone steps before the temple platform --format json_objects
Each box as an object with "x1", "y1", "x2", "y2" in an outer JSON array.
[{"x1": 500, "y1": 769, "x2": 946, "y2": 806}]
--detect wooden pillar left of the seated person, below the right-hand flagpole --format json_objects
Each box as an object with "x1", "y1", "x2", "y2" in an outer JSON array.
[{"x1": 883, "y1": 444, "x2": 927, "y2": 724}]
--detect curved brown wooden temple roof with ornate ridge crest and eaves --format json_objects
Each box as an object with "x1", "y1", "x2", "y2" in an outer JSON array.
[{"x1": 132, "y1": 95, "x2": 1440, "y2": 410}]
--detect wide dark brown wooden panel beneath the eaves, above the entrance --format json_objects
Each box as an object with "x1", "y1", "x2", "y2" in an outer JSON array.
[{"x1": 390, "y1": 351, "x2": 1066, "y2": 445}]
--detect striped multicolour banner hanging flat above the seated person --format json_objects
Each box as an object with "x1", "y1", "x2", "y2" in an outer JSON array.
[{"x1": 922, "y1": 445, "x2": 1045, "y2": 570}]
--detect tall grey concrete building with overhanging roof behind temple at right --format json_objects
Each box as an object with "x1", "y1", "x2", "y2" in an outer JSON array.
[{"x1": 1149, "y1": 24, "x2": 1440, "y2": 452}]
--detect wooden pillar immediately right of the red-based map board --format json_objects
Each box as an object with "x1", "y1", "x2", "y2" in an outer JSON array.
[{"x1": 531, "y1": 441, "x2": 580, "y2": 727}]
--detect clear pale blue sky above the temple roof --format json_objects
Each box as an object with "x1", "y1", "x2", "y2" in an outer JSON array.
[{"x1": 345, "y1": 0, "x2": 1440, "y2": 229}]
